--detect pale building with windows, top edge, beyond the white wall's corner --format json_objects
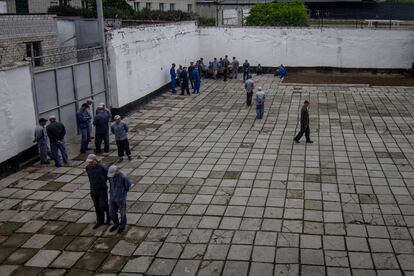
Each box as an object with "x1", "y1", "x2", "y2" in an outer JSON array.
[{"x1": 127, "y1": 0, "x2": 196, "y2": 13}]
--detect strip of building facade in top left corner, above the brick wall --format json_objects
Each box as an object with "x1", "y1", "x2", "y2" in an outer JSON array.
[{"x1": 0, "y1": 0, "x2": 87, "y2": 14}]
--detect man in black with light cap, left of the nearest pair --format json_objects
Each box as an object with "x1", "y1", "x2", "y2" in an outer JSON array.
[{"x1": 85, "y1": 154, "x2": 111, "y2": 229}]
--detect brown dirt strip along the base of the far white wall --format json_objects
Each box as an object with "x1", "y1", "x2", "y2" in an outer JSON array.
[{"x1": 282, "y1": 72, "x2": 414, "y2": 86}]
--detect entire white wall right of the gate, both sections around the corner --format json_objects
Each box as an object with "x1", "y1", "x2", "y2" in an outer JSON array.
[{"x1": 108, "y1": 22, "x2": 414, "y2": 110}]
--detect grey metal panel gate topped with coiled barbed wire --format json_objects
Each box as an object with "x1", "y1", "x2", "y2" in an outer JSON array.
[{"x1": 33, "y1": 55, "x2": 107, "y2": 139}]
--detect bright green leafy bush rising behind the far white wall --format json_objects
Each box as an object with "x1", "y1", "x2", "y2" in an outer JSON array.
[{"x1": 246, "y1": 1, "x2": 309, "y2": 26}]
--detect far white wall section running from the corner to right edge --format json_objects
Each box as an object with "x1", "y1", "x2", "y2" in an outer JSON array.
[{"x1": 200, "y1": 27, "x2": 414, "y2": 69}]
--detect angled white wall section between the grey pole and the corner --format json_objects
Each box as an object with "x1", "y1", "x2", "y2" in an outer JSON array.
[{"x1": 108, "y1": 22, "x2": 200, "y2": 107}]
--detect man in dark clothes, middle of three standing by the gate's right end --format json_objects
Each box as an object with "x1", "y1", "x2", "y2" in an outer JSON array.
[{"x1": 93, "y1": 106, "x2": 111, "y2": 153}]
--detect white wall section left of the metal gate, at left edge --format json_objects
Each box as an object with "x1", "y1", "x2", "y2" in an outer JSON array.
[{"x1": 0, "y1": 64, "x2": 36, "y2": 163}]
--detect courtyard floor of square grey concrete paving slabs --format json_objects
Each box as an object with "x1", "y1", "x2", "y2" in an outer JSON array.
[{"x1": 0, "y1": 76, "x2": 414, "y2": 276}]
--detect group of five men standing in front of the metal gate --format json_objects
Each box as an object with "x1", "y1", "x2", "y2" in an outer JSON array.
[{"x1": 33, "y1": 99, "x2": 132, "y2": 167}]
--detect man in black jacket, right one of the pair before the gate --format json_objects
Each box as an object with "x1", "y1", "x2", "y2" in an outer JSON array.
[{"x1": 46, "y1": 115, "x2": 69, "y2": 168}]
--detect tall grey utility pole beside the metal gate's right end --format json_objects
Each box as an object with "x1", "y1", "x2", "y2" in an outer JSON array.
[{"x1": 96, "y1": 0, "x2": 112, "y2": 107}]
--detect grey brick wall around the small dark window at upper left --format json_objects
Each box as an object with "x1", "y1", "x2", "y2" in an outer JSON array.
[{"x1": 0, "y1": 14, "x2": 59, "y2": 66}]
